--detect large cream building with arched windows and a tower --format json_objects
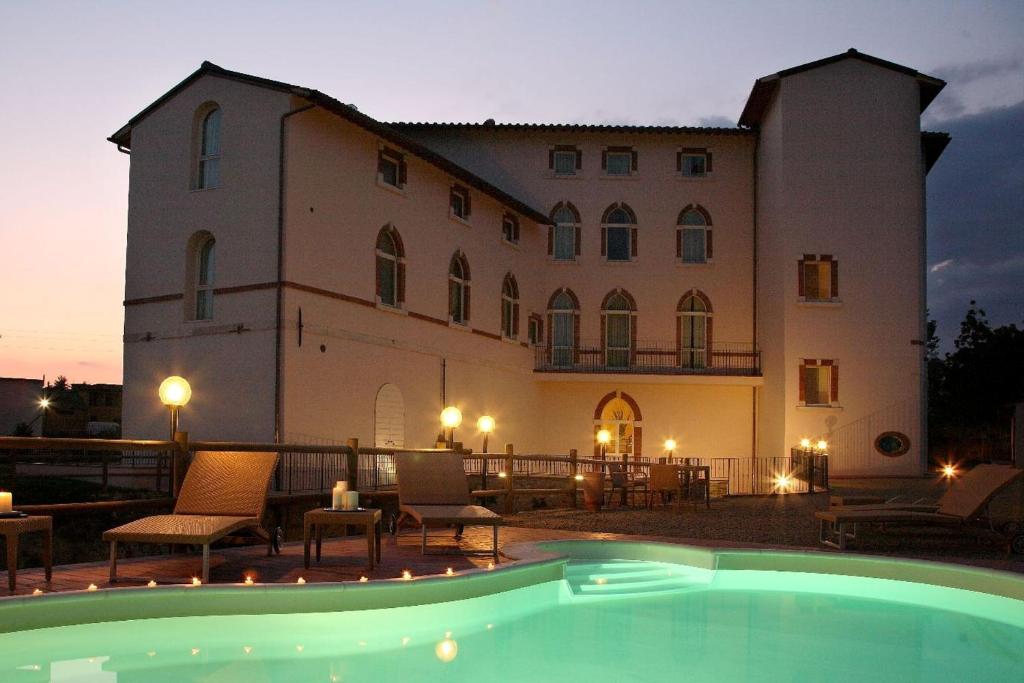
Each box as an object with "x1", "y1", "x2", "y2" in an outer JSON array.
[{"x1": 111, "y1": 50, "x2": 949, "y2": 474}]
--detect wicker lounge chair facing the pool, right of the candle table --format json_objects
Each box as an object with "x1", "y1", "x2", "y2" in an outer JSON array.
[{"x1": 394, "y1": 453, "x2": 502, "y2": 562}]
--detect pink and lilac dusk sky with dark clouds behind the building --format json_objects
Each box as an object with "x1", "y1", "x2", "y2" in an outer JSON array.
[{"x1": 0, "y1": 0, "x2": 1024, "y2": 382}]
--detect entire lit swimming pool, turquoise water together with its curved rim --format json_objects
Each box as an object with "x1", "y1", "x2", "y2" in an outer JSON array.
[{"x1": 0, "y1": 543, "x2": 1024, "y2": 683}]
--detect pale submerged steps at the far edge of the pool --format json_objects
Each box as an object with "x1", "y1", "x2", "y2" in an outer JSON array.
[{"x1": 565, "y1": 561, "x2": 712, "y2": 597}]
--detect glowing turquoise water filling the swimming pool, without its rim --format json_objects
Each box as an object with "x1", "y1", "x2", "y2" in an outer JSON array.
[{"x1": 0, "y1": 561, "x2": 1024, "y2": 683}]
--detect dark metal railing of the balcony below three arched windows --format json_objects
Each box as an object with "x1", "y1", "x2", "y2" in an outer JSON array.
[{"x1": 534, "y1": 340, "x2": 761, "y2": 377}]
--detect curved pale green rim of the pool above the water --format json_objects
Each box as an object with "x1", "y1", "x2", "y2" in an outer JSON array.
[{"x1": 0, "y1": 540, "x2": 1024, "y2": 634}]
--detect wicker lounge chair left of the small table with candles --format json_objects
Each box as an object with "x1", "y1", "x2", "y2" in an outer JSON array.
[{"x1": 103, "y1": 452, "x2": 278, "y2": 583}]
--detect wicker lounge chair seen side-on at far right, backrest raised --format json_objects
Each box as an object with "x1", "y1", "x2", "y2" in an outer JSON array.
[{"x1": 814, "y1": 465, "x2": 1024, "y2": 550}]
